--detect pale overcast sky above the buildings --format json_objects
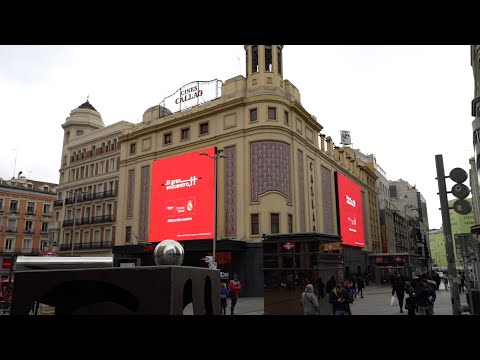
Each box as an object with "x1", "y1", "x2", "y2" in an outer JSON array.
[{"x1": 0, "y1": 45, "x2": 474, "y2": 228}]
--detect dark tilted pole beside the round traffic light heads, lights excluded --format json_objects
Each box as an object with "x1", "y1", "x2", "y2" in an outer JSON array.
[{"x1": 435, "y1": 155, "x2": 461, "y2": 315}]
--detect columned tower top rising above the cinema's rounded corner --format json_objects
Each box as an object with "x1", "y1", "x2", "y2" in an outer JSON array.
[{"x1": 245, "y1": 45, "x2": 284, "y2": 93}]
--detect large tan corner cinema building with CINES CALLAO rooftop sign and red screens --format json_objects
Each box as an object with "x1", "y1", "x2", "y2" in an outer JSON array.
[{"x1": 112, "y1": 45, "x2": 380, "y2": 296}]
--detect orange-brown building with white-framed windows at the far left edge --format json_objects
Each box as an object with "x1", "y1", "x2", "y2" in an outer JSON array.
[{"x1": 0, "y1": 176, "x2": 58, "y2": 277}]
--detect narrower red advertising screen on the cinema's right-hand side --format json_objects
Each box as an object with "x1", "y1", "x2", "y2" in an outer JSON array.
[{"x1": 335, "y1": 172, "x2": 365, "y2": 247}]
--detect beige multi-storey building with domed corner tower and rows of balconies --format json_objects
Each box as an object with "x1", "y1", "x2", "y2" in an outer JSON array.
[{"x1": 55, "y1": 100, "x2": 133, "y2": 256}]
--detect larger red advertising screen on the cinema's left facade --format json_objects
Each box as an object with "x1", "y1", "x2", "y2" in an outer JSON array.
[{"x1": 149, "y1": 147, "x2": 215, "y2": 242}]
